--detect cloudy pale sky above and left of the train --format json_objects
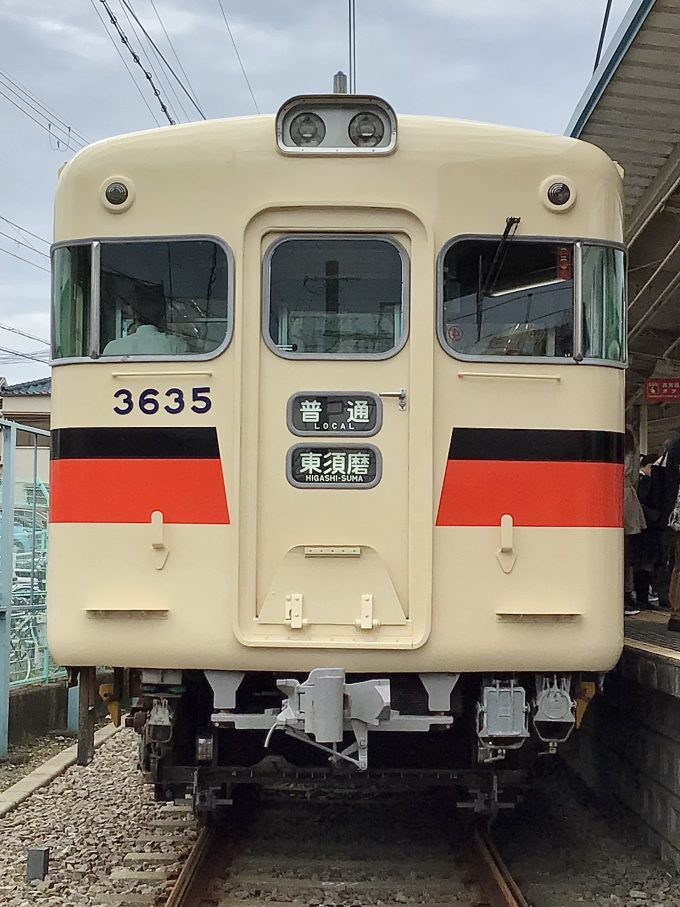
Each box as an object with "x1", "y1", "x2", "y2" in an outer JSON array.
[{"x1": 0, "y1": 0, "x2": 630, "y2": 383}]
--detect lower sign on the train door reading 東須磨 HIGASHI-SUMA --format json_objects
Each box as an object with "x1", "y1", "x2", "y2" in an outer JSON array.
[{"x1": 286, "y1": 444, "x2": 382, "y2": 488}]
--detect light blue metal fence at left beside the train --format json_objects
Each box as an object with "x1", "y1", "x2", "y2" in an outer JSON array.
[{"x1": 0, "y1": 419, "x2": 65, "y2": 755}]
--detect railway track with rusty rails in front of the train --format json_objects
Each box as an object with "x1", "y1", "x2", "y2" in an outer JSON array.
[{"x1": 164, "y1": 795, "x2": 529, "y2": 907}]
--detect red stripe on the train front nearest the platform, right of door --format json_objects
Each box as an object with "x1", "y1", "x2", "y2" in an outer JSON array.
[{"x1": 437, "y1": 460, "x2": 623, "y2": 528}]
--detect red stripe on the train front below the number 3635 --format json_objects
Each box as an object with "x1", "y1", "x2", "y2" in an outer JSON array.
[{"x1": 50, "y1": 459, "x2": 229, "y2": 524}]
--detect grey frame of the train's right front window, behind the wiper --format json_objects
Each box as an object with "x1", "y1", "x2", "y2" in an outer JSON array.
[{"x1": 436, "y1": 233, "x2": 628, "y2": 369}]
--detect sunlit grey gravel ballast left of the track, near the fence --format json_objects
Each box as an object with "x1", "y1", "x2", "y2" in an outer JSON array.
[{"x1": 0, "y1": 730, "x2": 195, "y2": 907}]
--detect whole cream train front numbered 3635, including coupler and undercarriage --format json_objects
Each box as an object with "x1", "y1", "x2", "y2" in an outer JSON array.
[{"x1": 48, "y1": 95, "x2": 626, "y2": 810}]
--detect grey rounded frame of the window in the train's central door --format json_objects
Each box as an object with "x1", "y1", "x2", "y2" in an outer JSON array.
[{"x1": 262, "y1": 230, "x2": 411, "y2": 362}]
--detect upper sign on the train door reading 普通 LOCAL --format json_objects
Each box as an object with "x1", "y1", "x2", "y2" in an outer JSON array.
[{"x1": 288, "y1": 391, "x2": 382, "y2": 438}]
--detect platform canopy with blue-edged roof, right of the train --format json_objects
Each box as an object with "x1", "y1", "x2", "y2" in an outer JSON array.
[{"x1": 567, "y1": 0, "x2": 680, "y2": 451}]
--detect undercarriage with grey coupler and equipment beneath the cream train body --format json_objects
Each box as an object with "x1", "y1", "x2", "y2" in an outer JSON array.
[{"x1": 114, "y1": 667, "x2": 595, "y2": 817}]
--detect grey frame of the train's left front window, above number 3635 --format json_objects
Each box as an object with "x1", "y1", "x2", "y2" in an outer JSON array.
[{"x1": 50, "y1": 233, "x2": 235, "y2": 367}]
